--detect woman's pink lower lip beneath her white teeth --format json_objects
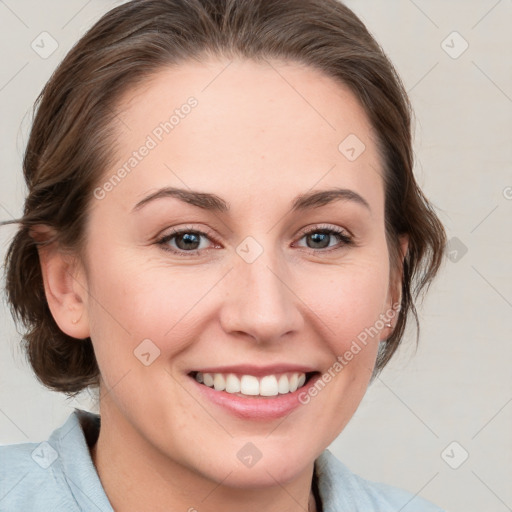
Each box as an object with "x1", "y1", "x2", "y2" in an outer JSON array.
[{"x1": 190, "y1": 374, "x2": 321, "y2": 420}]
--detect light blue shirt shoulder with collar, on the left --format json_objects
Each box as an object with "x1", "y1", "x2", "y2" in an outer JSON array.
[{"x1": 0, "y1": 410, "x2": 104, "y2": 512}]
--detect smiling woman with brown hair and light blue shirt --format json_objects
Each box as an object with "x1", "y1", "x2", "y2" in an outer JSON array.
[{"x1": 0, "y1": 0, "x2": 445, "y2": 512}]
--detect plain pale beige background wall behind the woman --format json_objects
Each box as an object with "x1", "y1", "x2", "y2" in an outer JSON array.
[{"x1": 0, "y1": 0, "x2": 512, "y2": 512}]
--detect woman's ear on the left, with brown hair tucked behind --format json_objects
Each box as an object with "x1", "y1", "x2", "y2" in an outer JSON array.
[{"x1": 30, "y1": 225, "x2": 90, "y2": 339}]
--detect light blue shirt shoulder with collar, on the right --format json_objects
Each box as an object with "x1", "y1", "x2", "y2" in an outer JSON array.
[{"x1": 315, "y1": 450, "x2": 443, "y2": 512}]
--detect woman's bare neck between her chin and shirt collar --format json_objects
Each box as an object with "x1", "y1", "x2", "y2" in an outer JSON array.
[{"x1": 91, "y1": 400, "x2": 320, "y2": 512}]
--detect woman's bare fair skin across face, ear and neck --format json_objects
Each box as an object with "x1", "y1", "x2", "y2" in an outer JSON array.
[{"x1": 40, "y1": 60, "x2": 407, "y2": 512}]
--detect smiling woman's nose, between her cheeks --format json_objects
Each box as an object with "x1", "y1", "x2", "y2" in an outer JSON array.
[{"x1": 220, "y1": 245, "x2": 303, "y2": 343}]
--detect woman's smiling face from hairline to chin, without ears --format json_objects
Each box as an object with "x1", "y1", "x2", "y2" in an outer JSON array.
[{"x1": 79, "y1": 60, "x2": 396, "y2": 487}]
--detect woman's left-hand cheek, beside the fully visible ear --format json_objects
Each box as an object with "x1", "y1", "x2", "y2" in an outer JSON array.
[{"x1": 84, "y1": 250, "x2": 214, "y2": 361}]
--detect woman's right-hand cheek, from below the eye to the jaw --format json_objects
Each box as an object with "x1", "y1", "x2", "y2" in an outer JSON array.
[{"x1": 294, "y1": 253, "x2": 388, "y2": 426}]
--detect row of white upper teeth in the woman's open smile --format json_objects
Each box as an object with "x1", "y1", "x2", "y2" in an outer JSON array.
[{"x1": 195, "y1": 372, "x2": 306, "y2": 396}]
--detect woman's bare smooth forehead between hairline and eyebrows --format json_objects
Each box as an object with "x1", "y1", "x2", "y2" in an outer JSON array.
[{"x1": 101, "y1": 60, "x2": 382, "y2": 215}]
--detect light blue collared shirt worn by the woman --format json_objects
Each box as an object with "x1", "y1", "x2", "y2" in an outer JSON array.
[{"x1": 0, "y1": 409, "x2": 443, "y2": 512}]
